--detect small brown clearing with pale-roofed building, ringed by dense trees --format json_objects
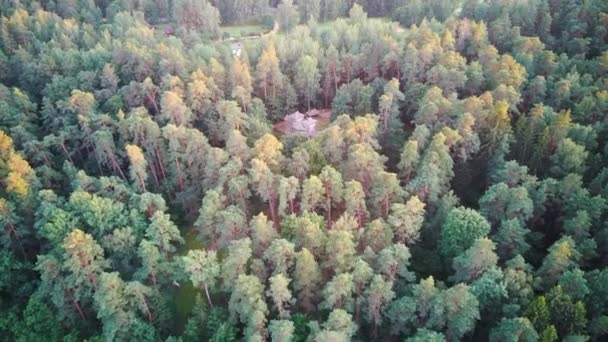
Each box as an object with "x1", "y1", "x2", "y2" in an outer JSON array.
[{"x1": 274, "y1": 109, "x2": 331, "y2": 137}]
